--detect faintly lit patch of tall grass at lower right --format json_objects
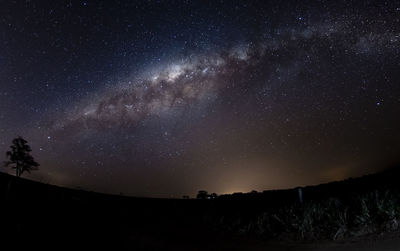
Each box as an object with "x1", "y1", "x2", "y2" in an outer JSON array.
[{"x1": 209, "y1": 190, "x2": 400, "y2": 240}]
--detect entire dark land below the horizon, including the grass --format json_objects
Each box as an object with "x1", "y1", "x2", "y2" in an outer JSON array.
[{"x1": 0, "y1": 170, "x2": 400, "y2": 251}]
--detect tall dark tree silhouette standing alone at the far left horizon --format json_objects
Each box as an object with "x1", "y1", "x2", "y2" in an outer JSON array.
[{"x1": 4, "y1": 136, "x2": 39, "y2": 177}]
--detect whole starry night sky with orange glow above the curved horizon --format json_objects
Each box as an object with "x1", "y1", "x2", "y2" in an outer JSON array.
[{"x1": 0, "y1": 0, "x2": 400, "y2": 197}]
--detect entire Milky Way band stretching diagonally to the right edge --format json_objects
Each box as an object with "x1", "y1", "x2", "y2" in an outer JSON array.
[{"x1": 57, "y1": 17, "x2": 400, "y2": 135}]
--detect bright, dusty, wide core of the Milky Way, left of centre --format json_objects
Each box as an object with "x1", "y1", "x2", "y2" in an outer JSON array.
[{"x1": 58, "y1": 50, "x2": 239, "y2": 133}]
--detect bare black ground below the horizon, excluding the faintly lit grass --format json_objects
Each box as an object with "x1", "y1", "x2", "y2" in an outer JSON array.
[{"x1": 0, "y1": 167, "x2": 400, "y2": 251}]
